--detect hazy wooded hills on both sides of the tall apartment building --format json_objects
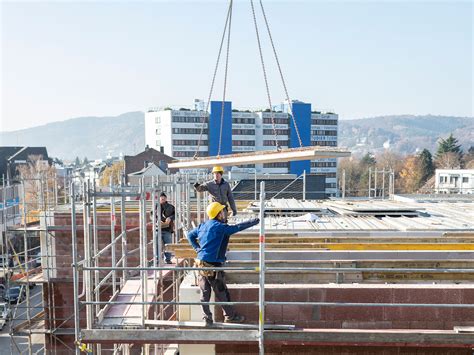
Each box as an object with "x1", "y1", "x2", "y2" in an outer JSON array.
[{"x1": 0, "y1": 111, "x2": 474, "y2": 160}]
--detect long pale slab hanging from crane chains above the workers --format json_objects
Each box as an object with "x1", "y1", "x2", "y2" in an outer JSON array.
[{"x1": 168, "y1": 146, "x2": 351, "y2": 169}]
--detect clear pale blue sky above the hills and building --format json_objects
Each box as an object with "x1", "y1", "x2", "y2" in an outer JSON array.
[{"x1": 0, "y1": 0, "x2": 474, "y2": 131}]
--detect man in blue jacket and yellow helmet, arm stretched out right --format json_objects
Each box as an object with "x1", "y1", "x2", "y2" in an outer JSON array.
[{"x1": 188, "y1": 202, "x2": 260, "y2": 326}]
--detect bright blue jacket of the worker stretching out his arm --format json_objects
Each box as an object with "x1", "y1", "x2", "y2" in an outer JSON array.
[{"x1": 188, "y1": 218, "x2": 260, "y2": 263}]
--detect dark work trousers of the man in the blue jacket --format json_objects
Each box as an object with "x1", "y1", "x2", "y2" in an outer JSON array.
[{"x1": 198, "y1": 271, "x2": 235, "y2": 319}]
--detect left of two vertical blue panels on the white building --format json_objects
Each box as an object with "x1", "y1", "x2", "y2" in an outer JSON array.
[{"x1": 208, "y1": 101, "x2": 232, "y2": 156}]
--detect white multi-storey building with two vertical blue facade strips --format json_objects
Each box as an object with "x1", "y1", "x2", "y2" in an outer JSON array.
[{"x1": 145, "y1": 100, "x2": 338, "y2": 196}]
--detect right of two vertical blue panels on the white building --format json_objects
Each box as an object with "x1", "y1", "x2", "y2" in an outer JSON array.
[{"x1": 290, "y1": 102, "x2": 311, "y2": 175}]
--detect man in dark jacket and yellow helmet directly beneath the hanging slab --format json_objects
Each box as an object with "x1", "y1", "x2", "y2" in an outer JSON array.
[{"x1": 194, "y1": 166, "x2": 237, "y2": 221}]
